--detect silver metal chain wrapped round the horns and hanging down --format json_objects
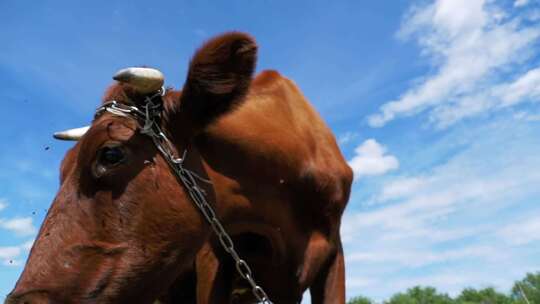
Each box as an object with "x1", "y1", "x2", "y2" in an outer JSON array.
[{"x1": 96, "y1": 93, "x2": 272, "y2": 304}]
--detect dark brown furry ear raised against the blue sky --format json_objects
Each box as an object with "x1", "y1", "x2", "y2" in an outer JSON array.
[{"x1": 180, "y1": 32, "x2": 257, "y2": 130}]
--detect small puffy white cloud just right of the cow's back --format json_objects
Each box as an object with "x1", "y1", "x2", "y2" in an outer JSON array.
[{"x1": 349, "y1": 139, "x2": 399, "y2": 178}]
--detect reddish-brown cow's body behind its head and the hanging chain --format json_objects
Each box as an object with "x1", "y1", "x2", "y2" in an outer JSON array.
[{"x1": 191, "y1": 71, "x2": 352, "y2": 303}]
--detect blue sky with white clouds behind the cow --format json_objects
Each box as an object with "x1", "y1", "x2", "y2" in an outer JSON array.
[{"x1": 0, "y1": 0, "x2": 540, "y2": 300}]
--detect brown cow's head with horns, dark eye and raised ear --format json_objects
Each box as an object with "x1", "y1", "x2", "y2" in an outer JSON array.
[{"x1": 6, "y1": 33, "x2": 256, "y2": 304}]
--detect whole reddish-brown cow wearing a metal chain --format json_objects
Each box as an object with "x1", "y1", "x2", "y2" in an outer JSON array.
[{"x1": 6, "y1": 33, "x2": 352, "y2": 304}]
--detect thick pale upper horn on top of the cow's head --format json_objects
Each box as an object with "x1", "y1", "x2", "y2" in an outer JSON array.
[{"x1": 113, "y1": 68, "x2": 165, "y2": 94}]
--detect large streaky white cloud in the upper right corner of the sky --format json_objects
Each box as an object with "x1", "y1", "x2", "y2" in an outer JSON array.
[{"x1": 368, "y1": 0, "x2": 540, "y2": 127}]
